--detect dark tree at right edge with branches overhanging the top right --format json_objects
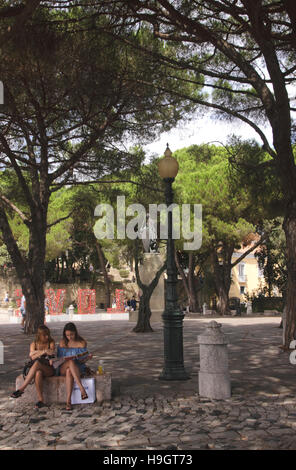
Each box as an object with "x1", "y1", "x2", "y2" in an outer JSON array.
[{"x1": 88, "y1": 0, "x2": 296, "y2": 345}]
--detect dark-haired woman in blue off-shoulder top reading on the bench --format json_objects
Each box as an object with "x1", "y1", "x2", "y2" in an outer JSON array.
[{"x1": 57, "y1": 323, "x2": 88, "y2": 411}]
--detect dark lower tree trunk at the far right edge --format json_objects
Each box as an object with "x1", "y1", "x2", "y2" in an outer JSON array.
[{"x1": 283, "y1": 201, "x2": 296, "y2": 348}]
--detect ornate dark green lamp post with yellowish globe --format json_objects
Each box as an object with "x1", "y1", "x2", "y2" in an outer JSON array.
[{"x1": 158, "y1": 145, "x2": 190, "y2": 380}]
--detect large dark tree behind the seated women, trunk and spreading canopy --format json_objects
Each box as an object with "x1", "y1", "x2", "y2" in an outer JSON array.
[{"x1": 0, "y1": 8, "x2": 199, "y2": 332}]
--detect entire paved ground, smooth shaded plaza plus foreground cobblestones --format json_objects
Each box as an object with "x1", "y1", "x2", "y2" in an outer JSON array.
[{"x1": 0, "y1": 317, "x2": 296, "y2": 450}]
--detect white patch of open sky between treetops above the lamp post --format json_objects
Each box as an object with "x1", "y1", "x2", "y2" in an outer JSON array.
[{"x1": 143, "y1": 115, "x2": 272, "y2": 156}]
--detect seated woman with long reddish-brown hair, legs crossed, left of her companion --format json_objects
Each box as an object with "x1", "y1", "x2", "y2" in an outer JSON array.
[{"x1": 10, "y1": 325, "x2": 55, "y2": 408}]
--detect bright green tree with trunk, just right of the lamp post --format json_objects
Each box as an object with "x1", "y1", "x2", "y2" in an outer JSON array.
[{"x1": 174, "y1": 143, "x2": 264, "y2": 314}]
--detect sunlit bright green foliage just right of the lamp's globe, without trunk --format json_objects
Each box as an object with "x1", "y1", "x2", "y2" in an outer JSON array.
[{"x1": 174, "y1": 142, "x2": 258, "y2": 247}]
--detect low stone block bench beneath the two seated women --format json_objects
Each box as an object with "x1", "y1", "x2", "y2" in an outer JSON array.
[{"x1": 16, "y1": 372, "x2": 111, "y2": 404}]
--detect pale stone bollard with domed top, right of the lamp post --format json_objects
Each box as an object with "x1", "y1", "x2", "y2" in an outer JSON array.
[{"x1": 197, "y1": 321, "x2": 231, "y2": 400}]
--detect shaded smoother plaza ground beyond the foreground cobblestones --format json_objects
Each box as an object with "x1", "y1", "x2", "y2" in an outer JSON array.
[{"x1": 0, "y1": 318, "x2": 295, "y2": 397}]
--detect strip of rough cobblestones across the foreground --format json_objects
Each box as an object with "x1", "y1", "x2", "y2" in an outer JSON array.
[{"x1": 0, "y1": 395, "x2": 296, "y2": 450}]
